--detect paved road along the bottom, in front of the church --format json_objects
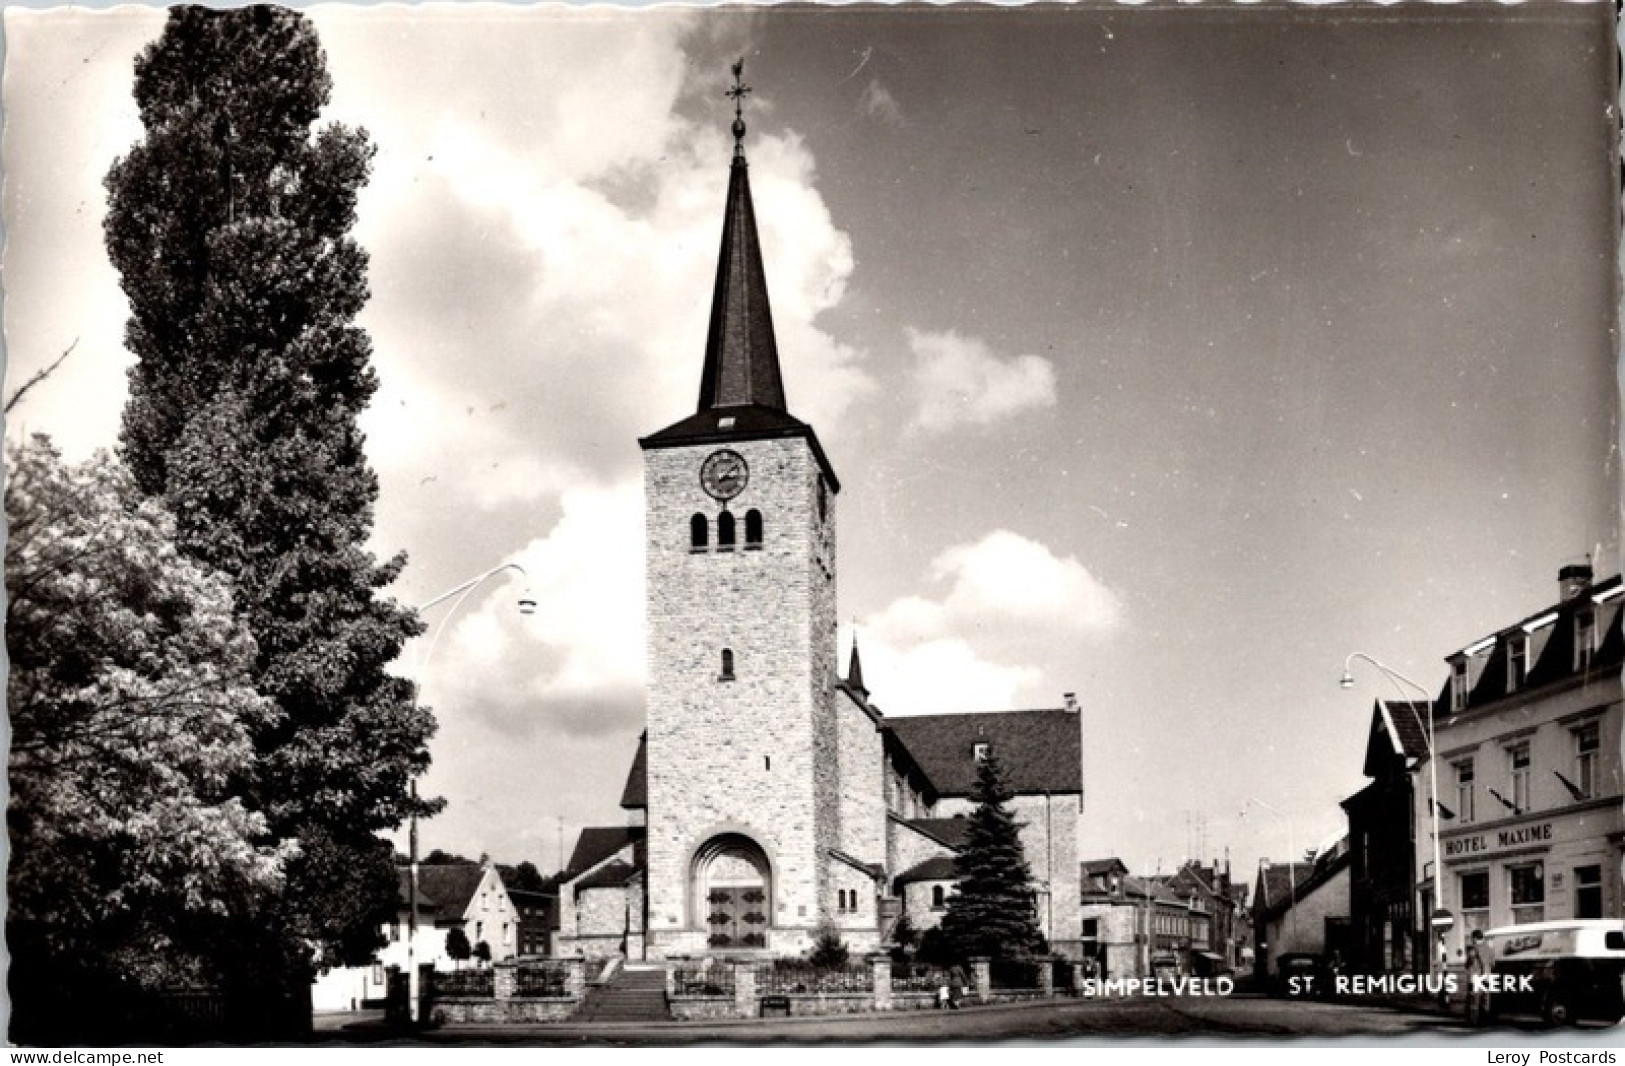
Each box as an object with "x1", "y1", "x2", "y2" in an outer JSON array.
[{"x1": 323, "y1": 996, "x2": 1488, "y2": 1045}]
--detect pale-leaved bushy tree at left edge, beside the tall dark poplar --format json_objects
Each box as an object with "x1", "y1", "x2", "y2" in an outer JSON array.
[{"x1": 5, "y1": 436, "x2": 294, "y2": 1042}]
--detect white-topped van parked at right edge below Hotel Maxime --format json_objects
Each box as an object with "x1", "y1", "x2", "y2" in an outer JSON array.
[{"x1": 1467, "y1": 918, "x2": 1625, "y2": 1025}]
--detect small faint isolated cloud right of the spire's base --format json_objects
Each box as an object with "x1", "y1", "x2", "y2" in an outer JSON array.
[{"x1": 908, "y1": 328, "x2": 1055, "y2": 432}]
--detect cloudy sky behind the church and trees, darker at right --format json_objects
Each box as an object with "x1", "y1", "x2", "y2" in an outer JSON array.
[{"x1": 0, "y1": 3, "x2": 1620, "y2": 876}]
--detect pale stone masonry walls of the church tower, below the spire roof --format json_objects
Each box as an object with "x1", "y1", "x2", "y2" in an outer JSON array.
[{"x1": 644, "y1": 439, "x2": 835, "y2": 956}]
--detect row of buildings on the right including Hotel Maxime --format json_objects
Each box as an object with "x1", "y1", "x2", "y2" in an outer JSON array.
[{"x1": 1253, "y1": 564, "x2": 1625, "y2": 975}]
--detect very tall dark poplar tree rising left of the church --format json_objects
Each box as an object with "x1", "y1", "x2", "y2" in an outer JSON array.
[{"x1": 106, "y1": 7, "x2": 432, "y2": 1014}]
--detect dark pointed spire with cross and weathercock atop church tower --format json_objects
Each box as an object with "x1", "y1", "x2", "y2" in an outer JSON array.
[{"x1": 699, "y1": 59, "x2": 785, "y2": 413}]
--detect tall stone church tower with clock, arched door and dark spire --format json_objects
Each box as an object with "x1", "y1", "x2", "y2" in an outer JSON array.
[{"x1": 640, "y1": 62, "x2": 840, "y2": 957}]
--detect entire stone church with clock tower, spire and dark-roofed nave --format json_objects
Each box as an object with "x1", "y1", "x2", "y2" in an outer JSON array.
[{"x1": 554, "y1": 67, "x2": 1084, "y2": 959}]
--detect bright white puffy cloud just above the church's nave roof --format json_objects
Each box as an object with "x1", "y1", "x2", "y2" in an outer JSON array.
[{"x1": 860, "y1": 530, "x2": 1121, "y2": 713}]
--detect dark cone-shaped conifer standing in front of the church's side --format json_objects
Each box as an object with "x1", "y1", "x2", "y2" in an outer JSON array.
[{"x1": 931, "y1": 752, "x2": 1047, "y2": 962}]
